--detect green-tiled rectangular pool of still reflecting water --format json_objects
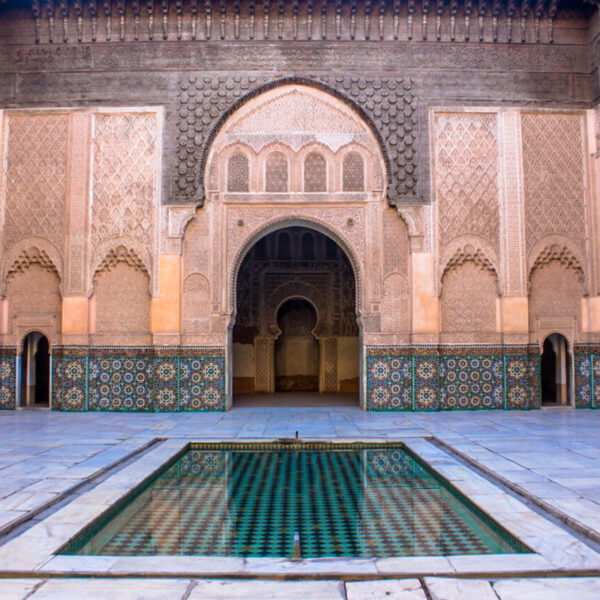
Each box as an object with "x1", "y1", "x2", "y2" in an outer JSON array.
[{"x1": 61, "y1": 444, "x2": 528, "y2": 558}]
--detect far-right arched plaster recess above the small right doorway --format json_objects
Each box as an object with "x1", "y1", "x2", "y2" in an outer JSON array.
[{"x1": 529, "y1": 243, "x2": 585, "y2": 344}]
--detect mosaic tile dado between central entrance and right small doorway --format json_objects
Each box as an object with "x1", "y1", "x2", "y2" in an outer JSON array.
[{"x1": 366, "y1": 346, "x2": 540, "y2": 410}]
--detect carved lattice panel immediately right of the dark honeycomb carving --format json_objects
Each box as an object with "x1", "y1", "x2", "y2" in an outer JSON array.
[{"x1": 434, "y1": 113, "x2": 499, "y2": 248}]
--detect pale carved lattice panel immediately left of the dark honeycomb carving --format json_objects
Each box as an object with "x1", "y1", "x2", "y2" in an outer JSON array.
[{"x1": 92, "y1": 113, "x2": 157, "y2": 247}]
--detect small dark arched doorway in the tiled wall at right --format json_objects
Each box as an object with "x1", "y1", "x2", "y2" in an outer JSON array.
[{"x1": 542, "y1": 333, "x2": 571, "y2": 406}]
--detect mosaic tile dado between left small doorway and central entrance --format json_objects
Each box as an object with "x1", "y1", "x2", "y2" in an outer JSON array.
[{"x1": 52, "y1": 346, "x2": 226, "y2": 412}]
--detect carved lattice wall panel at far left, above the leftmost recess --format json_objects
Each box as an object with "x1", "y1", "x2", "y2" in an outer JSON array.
[{"x1": 3, "y1": 115, "x2": 68, "y2": 250}]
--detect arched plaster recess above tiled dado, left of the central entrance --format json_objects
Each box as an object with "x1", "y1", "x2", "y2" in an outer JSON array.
[{"x1": 91, "y1": 245, "x2": 151, "y2": 346}]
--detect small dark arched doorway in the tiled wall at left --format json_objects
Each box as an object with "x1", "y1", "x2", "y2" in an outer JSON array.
[{"x1": 19, "y1": 331, "x2": 50, "y2": 408}]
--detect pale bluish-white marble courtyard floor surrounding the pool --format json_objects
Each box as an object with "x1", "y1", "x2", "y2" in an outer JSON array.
[{"x1": 0, "y1": 397, "x2": 600, "y2": 600}]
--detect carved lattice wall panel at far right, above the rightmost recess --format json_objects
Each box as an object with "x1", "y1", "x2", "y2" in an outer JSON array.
[{"x1": 521, "y1": 114, "x2": 585, "y2": 249}]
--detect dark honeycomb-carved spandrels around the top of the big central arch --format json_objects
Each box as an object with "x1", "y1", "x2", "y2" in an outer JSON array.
[{"x1": 171, "y1": 74, "x2": 419, "y2": 204}]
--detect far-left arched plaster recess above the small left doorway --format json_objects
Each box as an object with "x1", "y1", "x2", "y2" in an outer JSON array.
[{"x1": 6, "y1": 246, "x2": 62, "y2": 343}]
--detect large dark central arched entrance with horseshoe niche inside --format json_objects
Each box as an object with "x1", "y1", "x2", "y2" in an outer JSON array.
[{"x1": 232, "y1": 226, "x2": 359, "y2": 404}]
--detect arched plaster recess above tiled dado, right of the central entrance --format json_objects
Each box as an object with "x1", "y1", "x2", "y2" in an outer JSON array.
[{"x1": 440, "y1": 244, "x2": 499, "y2": 343}]
